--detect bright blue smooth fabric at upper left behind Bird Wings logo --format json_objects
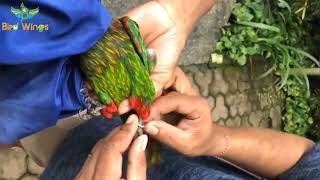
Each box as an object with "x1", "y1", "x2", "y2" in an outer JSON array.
[{"x1": 0, "y1": 0, "x2": 112, "y2": 143}]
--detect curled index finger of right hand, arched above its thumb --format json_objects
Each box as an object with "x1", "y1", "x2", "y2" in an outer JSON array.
[{"x1": 149, "y1": 92, "x2": 209, "y2": 120}]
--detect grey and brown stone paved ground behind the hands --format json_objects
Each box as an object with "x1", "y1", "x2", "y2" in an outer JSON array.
[{"x1": 0, "y1": 0, "x2": 282, "y2": 180}]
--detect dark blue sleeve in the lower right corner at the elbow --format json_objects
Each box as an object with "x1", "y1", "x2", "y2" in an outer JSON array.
[{"x1": 278, "y1": 143, "x2": 320, "y2": 180}]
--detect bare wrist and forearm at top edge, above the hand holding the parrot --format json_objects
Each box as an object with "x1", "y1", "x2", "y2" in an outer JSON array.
[{"x1": 157, "y1": 0, "x2": 215, "y2": 35}]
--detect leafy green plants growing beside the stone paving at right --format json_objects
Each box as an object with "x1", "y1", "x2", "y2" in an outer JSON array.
[{"x1": 215, "y1": 0, "x2": 320, "y2": 136}]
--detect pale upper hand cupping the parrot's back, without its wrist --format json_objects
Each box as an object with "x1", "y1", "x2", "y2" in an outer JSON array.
[{"x1": 126, "y1": 1, "x2": 188, "y2": 96}]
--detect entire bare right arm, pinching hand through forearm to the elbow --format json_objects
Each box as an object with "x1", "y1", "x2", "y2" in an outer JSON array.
[{"x1": 145, "y1": 71, "x2": 314, "y2": 177}]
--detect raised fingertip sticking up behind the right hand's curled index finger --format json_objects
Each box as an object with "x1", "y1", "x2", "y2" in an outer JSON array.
[{"x1": 165, "y1": 67, "x2": 199, "y2": 96}]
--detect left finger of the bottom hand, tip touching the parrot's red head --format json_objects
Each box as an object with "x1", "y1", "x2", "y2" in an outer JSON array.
[{"x1": 94, "y1": 115, "x2": 138, "y2": 179}]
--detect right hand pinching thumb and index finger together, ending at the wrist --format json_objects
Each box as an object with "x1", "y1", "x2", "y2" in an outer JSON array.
[{"x1": 145, "y1": 68, "x2": 225, "y2": 156}]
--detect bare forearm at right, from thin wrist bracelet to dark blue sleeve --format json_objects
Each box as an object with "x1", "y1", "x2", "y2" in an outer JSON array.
[{"x1": 210, "y1": 127, "x2": 314, "y2": 177}]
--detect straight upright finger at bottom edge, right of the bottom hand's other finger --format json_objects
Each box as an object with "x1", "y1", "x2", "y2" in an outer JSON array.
[{"x1": 127, "y1": 135, "x2": 148, "y2": 180}]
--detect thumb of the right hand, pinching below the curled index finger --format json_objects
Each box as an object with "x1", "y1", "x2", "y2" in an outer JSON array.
[{"x1": 144, "y1": 121, "x2": 188, "y2": 151}]
